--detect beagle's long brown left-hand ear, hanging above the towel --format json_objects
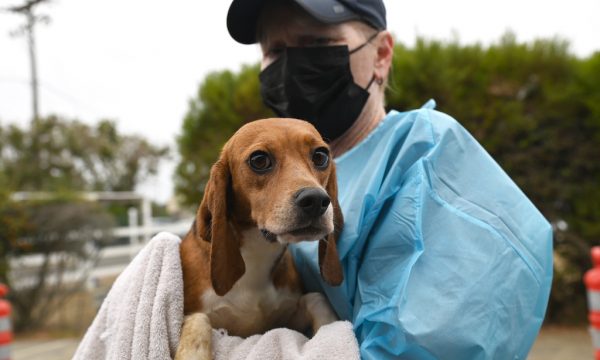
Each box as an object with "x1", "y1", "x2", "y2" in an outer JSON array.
[{"x1": 196, "y1": 156, "x2": 246, "y2": 296}]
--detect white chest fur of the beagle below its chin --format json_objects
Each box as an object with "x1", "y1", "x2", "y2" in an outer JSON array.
[{"x1": 202, "y1": 232, "x2": 301, "y2": 336}]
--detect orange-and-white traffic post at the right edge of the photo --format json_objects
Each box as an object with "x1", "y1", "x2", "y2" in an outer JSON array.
[{"x1": 583, "y1": 246, "x2": 600, "y2": 360}]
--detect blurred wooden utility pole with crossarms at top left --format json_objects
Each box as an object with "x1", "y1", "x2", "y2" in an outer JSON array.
[{"x1": 4, "y1": 0, "x2": 50, "y2": 121}]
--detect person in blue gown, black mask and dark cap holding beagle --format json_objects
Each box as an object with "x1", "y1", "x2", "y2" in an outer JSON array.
[{"x1": 227, "y1": 0, "x2": 552, "y2": 359}]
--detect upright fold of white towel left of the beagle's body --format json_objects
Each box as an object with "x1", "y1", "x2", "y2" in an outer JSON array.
[{"x1": 73, "y1": 233, "x2": 183, "y2": 360}]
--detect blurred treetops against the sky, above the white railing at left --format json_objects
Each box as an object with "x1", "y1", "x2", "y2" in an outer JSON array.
[{"x1": 0, "y1": 116, "x2": 168, "y2": 191}]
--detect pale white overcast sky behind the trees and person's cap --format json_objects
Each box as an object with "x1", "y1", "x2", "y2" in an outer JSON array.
[{"x1": 0, "y1": 0, "x2": 600, "y2": 202}]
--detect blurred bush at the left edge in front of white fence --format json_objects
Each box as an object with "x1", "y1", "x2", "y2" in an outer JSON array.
[{"x1": 0, "y1": 198, "x2": 113, "y2": 331}]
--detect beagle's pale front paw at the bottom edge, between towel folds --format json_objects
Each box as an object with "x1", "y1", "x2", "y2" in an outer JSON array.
[{"x1": 175, "y1": 313, "x2": 212, "y2": 360}]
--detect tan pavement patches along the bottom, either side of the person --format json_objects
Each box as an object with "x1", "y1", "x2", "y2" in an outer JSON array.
[{"x1": 7, "y1": 326, "x2": 594, "y2": 360}]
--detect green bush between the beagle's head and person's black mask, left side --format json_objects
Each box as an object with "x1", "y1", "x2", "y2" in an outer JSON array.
[{"x1": 175, "y1": 66, "x2": 272, "y2": 206}]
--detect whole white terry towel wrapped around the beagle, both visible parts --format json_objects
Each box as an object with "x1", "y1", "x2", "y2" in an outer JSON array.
[{"x1": 73, "y1": 233, "x2": 360, "y2": 360}]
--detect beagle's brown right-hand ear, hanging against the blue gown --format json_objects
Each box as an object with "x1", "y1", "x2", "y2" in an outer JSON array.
[{"x1": 319, "y1": 163, "x2": 344, "y2": 286}]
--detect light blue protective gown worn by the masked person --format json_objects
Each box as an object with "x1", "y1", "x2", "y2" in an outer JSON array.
[{"x1": 292, "y1": 101, "x2": 552, "y2": 360}]
